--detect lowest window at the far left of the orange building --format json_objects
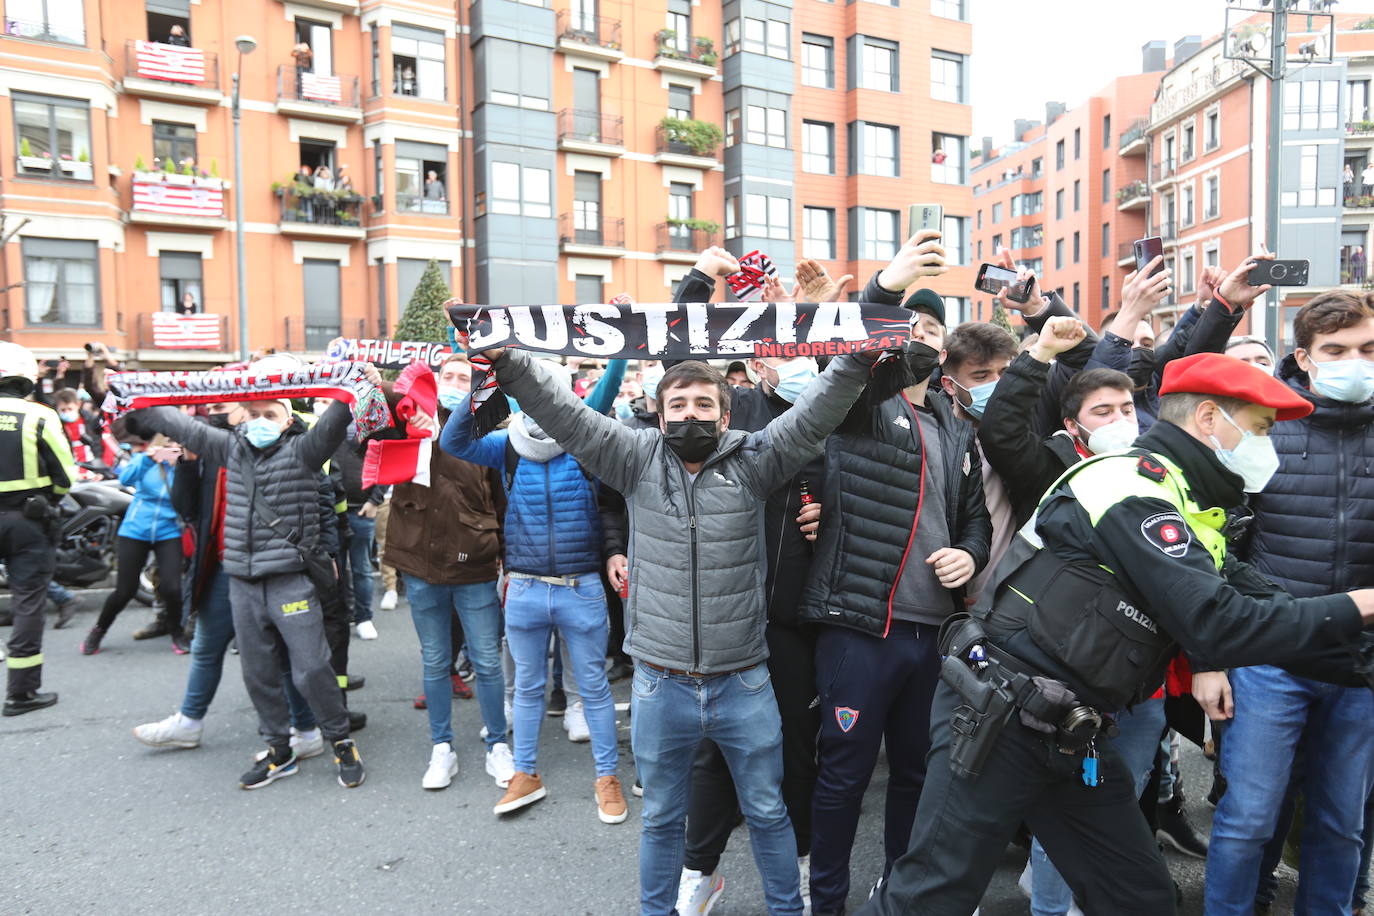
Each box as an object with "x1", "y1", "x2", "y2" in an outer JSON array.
[{"x1": 22, "y1": 239, "x2": 100, "y2": 327}]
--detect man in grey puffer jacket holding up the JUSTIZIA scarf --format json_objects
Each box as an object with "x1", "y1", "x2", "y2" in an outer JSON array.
[{"x1": 445, "y1": 233, "x2": 945, "y2": 916}]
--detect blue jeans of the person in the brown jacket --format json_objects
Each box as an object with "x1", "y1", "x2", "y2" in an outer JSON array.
[{"x1": 403, "y1": 573, "x2": 506, "y2": 748}]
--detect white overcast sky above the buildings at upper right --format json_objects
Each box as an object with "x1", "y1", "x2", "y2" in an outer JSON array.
[{"x1": 969, "y1": 0, "x2": 1374, "y2": 150}]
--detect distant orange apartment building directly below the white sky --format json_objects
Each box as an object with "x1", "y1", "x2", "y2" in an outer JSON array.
[{"x1": 973, "y1": 41, "x2": 1184, "y2": 333}]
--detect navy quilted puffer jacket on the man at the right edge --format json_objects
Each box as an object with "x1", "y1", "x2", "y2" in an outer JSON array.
[{"x1": 1243, "y1": 356, "x2": 1374, "y2": 597}]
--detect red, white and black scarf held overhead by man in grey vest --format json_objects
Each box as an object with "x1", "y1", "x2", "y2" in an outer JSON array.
[{"x1": 104, "y1": 363, "x2": 392, "y2": 439}]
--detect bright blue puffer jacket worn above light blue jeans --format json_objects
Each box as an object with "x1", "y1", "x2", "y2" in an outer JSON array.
[{"x1": 440, "y1": 360, "x2": 625, "y2": 575}]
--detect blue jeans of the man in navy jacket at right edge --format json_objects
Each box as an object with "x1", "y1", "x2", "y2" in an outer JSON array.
[{"x1": 1206, "y1": 665, "x2": 1374, "y2": 916}]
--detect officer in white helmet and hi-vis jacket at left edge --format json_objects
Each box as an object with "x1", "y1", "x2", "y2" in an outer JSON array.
[{"x1": 0, "y1": 341, "x2": 76, "y2": 715}]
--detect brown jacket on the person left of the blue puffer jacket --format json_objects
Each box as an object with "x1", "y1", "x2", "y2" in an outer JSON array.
[{"x1": 385, "y1": 411, "x2": 506, "y2": 585}]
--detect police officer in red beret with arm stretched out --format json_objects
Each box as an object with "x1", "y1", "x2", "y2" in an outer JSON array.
[{"x1": 860, "y1": 347, "x2": 1374, "y2": 916}]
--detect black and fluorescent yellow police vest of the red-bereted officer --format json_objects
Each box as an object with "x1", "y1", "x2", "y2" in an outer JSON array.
[{"x1": 987, "y1": 449, "x2": 1226, "y2": 709}]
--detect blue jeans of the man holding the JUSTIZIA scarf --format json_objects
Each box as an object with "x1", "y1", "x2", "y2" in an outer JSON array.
[{"x1": 631, "y1": 662, "x2": 801, "y2": 916}]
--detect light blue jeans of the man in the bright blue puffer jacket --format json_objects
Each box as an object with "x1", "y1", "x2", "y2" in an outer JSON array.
[{"x1": 506, "y1": 573, "x2": 620, "y2": 776}]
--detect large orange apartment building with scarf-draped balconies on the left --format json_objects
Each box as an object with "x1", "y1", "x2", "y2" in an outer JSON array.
[{"x1": 0, "y1": 0, "x2": 973, "y2": 367}]
